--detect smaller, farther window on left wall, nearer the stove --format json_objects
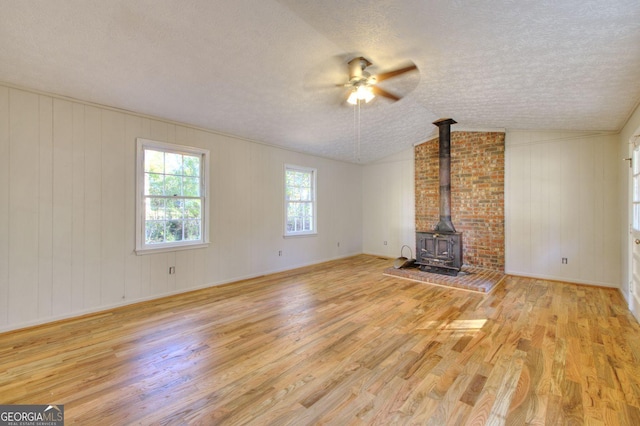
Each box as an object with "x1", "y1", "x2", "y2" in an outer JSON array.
[{"x1": 284, "y1": 165, "x2": 316, "y2": 236}]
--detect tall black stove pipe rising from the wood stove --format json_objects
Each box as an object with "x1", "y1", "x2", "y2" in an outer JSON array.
[{"x1": 433, "y1": 118, "x2": 457, "y2": 232}]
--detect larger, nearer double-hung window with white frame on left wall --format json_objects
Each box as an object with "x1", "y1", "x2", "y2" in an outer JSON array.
[{"x1": 136, "y1": 138, "x2": 209, "y2": 254}]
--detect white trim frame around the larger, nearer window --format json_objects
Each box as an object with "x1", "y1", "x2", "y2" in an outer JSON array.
[{"x1": 135, "y1": 138, "x2": 210, "y2": 255}]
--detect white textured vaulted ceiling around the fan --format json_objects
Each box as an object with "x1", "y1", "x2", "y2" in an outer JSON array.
[{"x1": 0, "y1": 0, "x2": 640, "y2": 163}]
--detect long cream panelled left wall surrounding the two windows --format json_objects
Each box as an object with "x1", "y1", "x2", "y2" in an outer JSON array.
[{"x1": 0, "y1": 86, "x2": 362, "y2": 330}]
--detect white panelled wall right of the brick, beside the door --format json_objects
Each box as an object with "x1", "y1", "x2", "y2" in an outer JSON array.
[{"x1": 505, "y1": 131, "x2": 625, "y2": 287}]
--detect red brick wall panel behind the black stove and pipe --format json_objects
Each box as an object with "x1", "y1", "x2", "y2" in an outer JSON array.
[{"x1": 415, "y1": 131, "x2": 504, "y2": 271}]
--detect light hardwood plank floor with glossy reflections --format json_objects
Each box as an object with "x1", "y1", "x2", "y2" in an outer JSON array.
[{"x1": 0, "y1": 255, "x2": 640, "y2": 425}]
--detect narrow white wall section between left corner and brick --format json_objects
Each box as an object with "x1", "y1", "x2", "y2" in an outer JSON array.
[{"x1": 362, "y1": 148, "x2": 415, "y2": 258}]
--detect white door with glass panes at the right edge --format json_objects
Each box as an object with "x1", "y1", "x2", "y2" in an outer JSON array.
[{"x1": 629, "y1": 137, "x2": 640, "y2": 320}]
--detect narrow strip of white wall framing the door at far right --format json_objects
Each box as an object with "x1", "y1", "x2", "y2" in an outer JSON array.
[{"x1": 617, "y1": 103, "x2": 640, "y2": 310}]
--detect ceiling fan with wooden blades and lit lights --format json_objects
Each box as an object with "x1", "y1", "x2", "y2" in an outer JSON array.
[{"x1": 338, "y1": 56, "x2": 418, "y2": 105}]
